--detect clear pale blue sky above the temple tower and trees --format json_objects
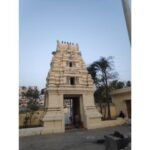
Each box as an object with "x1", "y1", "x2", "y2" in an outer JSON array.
[{"x1": 19, "y1": 0, "x2": 131, "y2": 89}]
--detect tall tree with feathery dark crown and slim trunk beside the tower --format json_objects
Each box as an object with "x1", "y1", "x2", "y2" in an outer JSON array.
[{"x1": 89, "y1": 56, "x2": 118, "y2": 119}]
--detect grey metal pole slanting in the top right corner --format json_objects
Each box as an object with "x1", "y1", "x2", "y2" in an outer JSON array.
[{"x1": 122, "y1": 0, "x2": 131, "y2": 43}]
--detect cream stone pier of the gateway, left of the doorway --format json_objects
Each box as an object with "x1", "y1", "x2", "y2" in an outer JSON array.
[{"x1": 42, "y1": 92, "x2": 65, "y2": 134}]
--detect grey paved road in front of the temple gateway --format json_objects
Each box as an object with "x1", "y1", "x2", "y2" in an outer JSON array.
[{"x1": 19, "y1": 125, "x2": 131, "y2": 150}]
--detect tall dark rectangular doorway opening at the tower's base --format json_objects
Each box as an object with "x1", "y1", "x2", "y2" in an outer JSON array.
[{"x1": 64, "y1": 96, "x2": 81, "y2": 129}]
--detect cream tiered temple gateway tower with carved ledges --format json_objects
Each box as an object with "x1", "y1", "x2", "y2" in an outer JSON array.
[{"x1": 43, "y1": 41, "x2": 101, "y2": 133}]
